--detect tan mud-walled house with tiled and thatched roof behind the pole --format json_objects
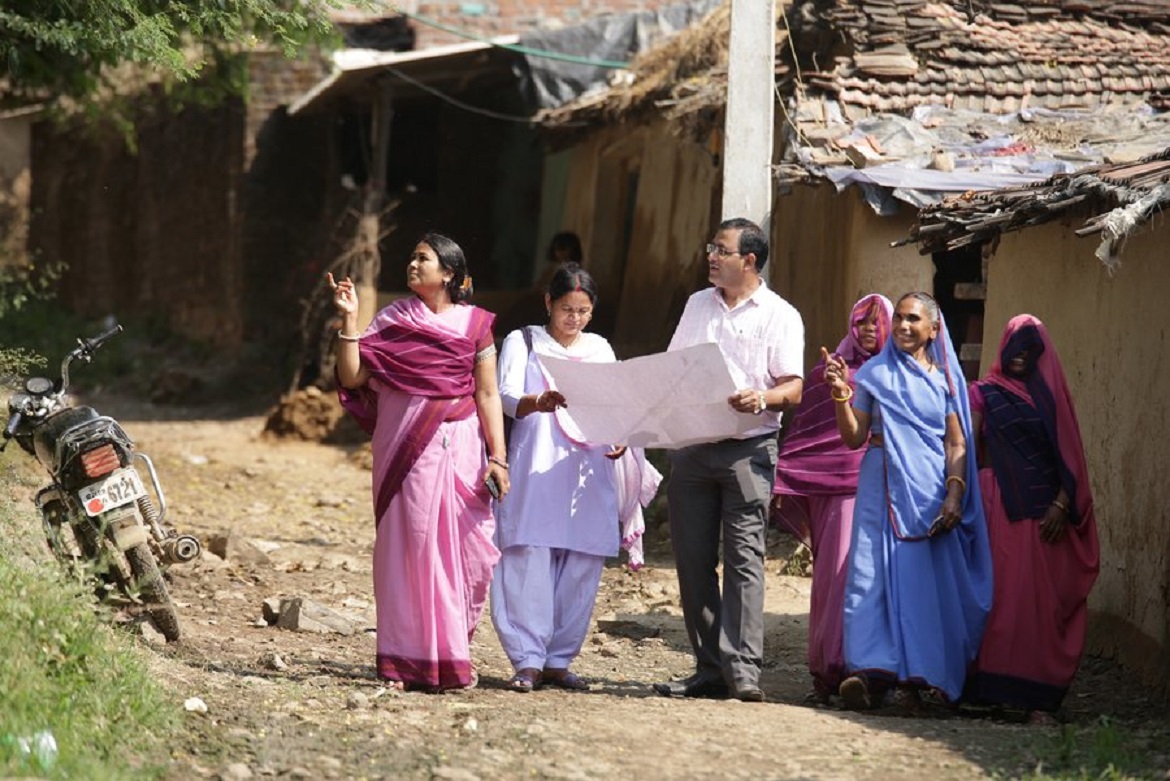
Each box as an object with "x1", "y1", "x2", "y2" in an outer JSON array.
[{"x1": 542, "y1": 0, "x2": 1170, "y2": 689}]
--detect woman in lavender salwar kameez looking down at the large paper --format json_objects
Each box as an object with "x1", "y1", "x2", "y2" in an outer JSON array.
[{"x1": 491, "y1": 263, "x2": 661, "y2": 692}]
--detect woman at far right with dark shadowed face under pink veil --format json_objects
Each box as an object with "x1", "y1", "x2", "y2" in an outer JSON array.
[{"x1": 966, "y1": 315, "x2": 1097, "y2": 724}]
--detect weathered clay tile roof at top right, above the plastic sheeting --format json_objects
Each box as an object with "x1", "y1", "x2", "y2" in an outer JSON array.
[{"x1": 809, "y1": 0, "x2": 1170, "y2": 119}]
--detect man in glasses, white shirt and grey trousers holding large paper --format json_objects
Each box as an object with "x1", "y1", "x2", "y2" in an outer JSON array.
[{"x1": 654, "y1": 217, "x2": 804, "y2": 703}]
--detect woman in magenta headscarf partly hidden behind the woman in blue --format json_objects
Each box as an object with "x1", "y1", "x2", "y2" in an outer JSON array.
[{"x1": 772, "y1": 293, "x2": 894, "y2": 701}]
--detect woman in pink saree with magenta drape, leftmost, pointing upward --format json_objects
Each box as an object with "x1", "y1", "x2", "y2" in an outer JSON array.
[{"x1": 330, "y1": 234, "x2": 509, "y2": 691}]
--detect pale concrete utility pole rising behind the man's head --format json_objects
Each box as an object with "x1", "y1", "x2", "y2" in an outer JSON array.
[{"x1": 723, "y1": 0, "x2": 776, "y2": 233}]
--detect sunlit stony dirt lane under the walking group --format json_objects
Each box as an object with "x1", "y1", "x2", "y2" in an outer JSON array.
[{"x1": 73, "y1": 392, "x2": 1170, "y2": 780}]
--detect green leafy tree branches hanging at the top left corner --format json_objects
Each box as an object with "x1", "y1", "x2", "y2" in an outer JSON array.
[{"x1": 0, "y1": 0, "x2": 355, "y2": 104}]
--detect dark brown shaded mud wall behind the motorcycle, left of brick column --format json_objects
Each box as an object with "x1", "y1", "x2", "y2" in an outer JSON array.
[{"x1": 29, "y1": 101, "x2": 243, "y2": 345}]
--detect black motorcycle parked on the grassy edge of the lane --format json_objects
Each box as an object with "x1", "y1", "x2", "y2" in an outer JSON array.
[{"x1": 0, "y1": 325, "x2": 200, "y2": 642}]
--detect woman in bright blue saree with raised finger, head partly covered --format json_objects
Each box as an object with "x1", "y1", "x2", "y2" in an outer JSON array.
[{"x1": 825, "y1": 293, "x2": 991, "y2": 711}]
